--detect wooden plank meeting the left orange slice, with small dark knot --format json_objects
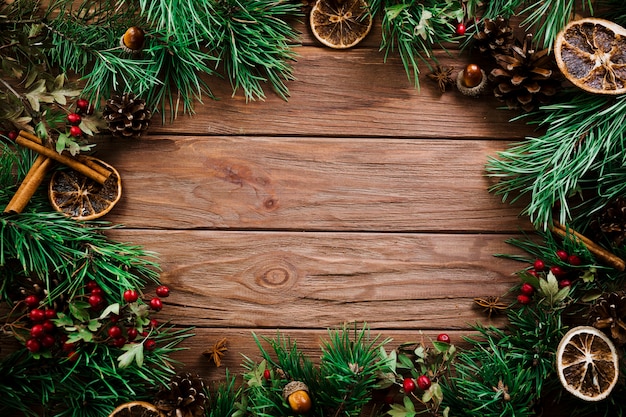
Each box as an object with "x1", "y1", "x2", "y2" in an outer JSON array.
[{"x1": 98, "y1": 136, "x2": 528, "y2": 232}]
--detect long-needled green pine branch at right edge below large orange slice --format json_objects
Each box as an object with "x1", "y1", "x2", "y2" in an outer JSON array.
[{"x1": 487, "y1": 92, "x2": 626, "y2": 229}]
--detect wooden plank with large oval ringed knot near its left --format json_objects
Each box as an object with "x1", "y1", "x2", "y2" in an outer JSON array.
[{"x1": 109, "y1": 229, "x2": 522, "y2": 331}]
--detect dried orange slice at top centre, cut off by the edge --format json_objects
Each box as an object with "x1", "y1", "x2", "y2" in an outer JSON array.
[{"x1": 310, "y1": 0, "x2": 372, "y2": 49}]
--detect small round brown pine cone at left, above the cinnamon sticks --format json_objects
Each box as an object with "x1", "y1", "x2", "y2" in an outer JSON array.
[{"x1": 102, "y1": 93, "x2": 152, "y2": 138}]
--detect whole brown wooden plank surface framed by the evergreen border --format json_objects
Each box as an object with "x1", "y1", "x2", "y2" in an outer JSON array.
[{"x1": 88, "y1": 18, "x2": 533, "y2": 386}]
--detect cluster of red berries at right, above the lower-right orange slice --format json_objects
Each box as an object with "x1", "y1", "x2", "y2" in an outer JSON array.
[{"x1": 517, "y1": 249, "x2": 582, "y2": 304}]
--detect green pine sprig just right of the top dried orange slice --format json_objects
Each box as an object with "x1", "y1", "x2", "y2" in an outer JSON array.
[{"x1": 371, "y1": 0, "x2": 464, "y2": 87}]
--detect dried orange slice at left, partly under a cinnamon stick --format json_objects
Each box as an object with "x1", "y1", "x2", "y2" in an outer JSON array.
[{"x1": 48, "y1": 157, "x2": 122, "y2": 220}]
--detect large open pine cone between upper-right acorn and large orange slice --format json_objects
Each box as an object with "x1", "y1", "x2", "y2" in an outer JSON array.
[{"x1": 489, "y1": 35, "x2": 560, "y2": 111}]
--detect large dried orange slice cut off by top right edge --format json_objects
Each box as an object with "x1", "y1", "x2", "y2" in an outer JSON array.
[{"x1": 554, "y1": 18, "x2": 626, "y2": 94}]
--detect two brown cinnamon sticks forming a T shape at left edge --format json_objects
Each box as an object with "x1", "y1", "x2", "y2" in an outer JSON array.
[{"x1": 4, "y1": 130, "x2": 111, "y2": 213}]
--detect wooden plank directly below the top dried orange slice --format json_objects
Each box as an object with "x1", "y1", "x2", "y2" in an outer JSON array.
[{"x1": 150, "y1": 46, "x2": 532, "y2": 139}]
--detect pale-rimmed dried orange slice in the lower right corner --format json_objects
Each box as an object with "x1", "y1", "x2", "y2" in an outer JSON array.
[{"x1": 556, "y1": 326, "x2": 619, "y2": 401}]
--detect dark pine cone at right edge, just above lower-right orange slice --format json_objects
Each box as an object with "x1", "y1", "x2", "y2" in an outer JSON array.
[{"x1": 591, "y1": 291, "x2": 626, "y2": 345}]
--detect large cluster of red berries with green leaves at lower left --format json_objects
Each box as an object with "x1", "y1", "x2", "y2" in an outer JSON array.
[{"x1": 19, "y1": 281, "x2": 170, "y2": 361}]
